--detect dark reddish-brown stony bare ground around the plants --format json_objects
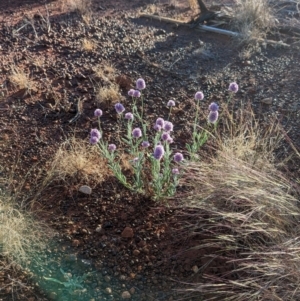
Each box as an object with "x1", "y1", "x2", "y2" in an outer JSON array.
[{"x1": 0, "y1": 0, "x2": 300, "y2": 301}]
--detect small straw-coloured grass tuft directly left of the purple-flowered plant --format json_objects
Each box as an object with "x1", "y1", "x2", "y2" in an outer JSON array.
[{"x1": 49, "y1": 138, "x2": 110, "y2": 183}]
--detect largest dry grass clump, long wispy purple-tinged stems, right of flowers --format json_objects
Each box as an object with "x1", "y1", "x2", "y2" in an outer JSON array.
[{"x1": 179, "y1": 105, "x2": 300, "y2": 301}]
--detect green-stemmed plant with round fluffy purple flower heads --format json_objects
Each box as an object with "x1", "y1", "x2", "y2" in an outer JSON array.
[{"x1": 90, "y1": 78, "x2": 230, "y2": 200}]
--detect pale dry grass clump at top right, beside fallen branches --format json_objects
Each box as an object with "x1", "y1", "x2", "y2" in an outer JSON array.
[{"x1": 233, "y1": 0, "x2": 276, "y2": 41}]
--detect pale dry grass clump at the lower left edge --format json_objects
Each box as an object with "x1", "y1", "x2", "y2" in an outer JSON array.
[{"x1": 0, "y1": 195, "x2": 50, "y2": 270}]
